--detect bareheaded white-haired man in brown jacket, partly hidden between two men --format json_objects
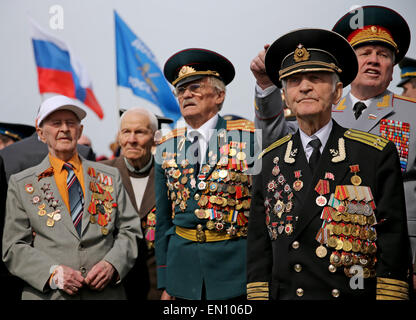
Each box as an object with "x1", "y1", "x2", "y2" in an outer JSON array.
[{"x1": 103, "y1": 108, "x2": 166, "y2": 300}]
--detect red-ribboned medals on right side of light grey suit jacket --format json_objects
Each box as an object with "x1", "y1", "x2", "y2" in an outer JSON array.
[{"x1": 89, "y1": 174, "x2": 114, "y2": 236}]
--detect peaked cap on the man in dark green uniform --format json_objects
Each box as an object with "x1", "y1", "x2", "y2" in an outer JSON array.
[{"x1": 163, "y1": 48, "x2": 235, "y2": 86}]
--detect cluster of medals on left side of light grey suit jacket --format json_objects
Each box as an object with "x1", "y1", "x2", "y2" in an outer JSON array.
[{"x1": 30, "y1": 183, "x2": 62, "y2": 227}]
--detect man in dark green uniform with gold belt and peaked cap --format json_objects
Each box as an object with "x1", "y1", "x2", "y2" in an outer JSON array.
[{"x1": 155, "y1": 49, "x2": 255, "y2": 300}]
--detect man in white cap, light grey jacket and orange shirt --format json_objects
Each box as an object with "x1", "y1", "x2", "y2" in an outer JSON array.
[{"x1": 2, "y1": 95, "x2": 142, "y2": 300}]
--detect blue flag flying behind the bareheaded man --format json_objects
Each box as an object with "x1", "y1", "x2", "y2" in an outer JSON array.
[{"x1": 114, "y1": 11, "x2": 181, "y2": 122}]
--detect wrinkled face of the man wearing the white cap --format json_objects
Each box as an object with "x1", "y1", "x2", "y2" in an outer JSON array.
[{"x1": 37, "y1": 110, "x2": 83, "y2": 161}]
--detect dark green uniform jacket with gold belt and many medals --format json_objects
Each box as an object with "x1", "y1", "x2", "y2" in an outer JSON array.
[{"x1": 155, "y1": 117, "x2": 255, "y2": 299}]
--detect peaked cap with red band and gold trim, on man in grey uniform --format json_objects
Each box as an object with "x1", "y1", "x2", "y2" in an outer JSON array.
[{"x1": 332, "y1": 6, "x2": 410, "y2": 63}]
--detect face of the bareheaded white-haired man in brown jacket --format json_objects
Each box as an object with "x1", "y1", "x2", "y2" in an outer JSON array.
[{"x1": 118, "y1": 111, "x2": 154, "y2": 163}]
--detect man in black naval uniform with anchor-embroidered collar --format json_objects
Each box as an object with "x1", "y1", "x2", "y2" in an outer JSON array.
[{"x1": 247, "y1": 29, "x2": 410, "y2": 299}]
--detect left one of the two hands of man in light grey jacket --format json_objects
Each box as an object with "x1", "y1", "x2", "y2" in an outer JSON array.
[{"x1": 50, "y1": 265, "x2": 85, "y2": 295}]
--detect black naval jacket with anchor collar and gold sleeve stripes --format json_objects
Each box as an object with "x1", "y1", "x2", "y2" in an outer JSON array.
[{"x1": 247, "y1": 121, "x2": 410, "y2": 299}]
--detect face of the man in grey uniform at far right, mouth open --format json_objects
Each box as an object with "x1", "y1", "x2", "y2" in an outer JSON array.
[{"x1": 351, "y1": 45, "x2": 394, "y2": 94}]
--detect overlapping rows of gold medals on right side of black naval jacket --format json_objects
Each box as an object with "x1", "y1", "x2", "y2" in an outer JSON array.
[{"x1": 315, "y1": 171, "x2": 377, "y2": 278}]
